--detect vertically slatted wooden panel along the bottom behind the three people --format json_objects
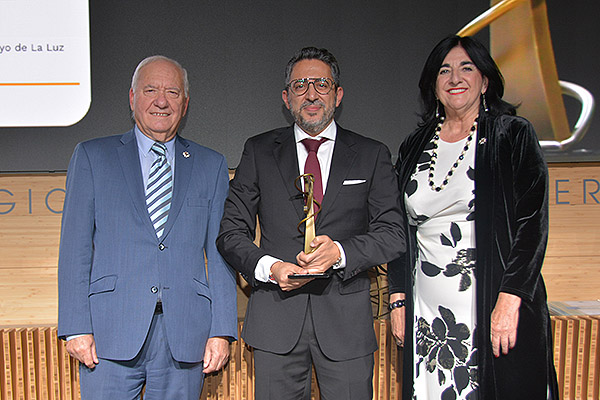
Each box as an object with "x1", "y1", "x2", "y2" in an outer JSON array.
[{"x1": 0, "y1": 316, "x2": 600, "y2": 400}]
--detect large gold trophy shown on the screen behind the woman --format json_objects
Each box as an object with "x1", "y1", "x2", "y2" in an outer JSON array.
[{"x1": 458, "y1": 0, "x2": 594, "y2": 150}]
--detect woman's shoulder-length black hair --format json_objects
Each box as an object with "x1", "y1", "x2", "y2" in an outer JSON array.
[{"x1": 419, "y1": 35, "x2": 517, "y2": 124}]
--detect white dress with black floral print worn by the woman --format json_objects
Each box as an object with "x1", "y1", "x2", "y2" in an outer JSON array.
[{"x1": 405, "y1": 134, "x2": 477, "y2": 400}]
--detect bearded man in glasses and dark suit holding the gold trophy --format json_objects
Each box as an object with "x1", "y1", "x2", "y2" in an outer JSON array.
[{"x1": 217, "y1": 47, "x2": 405, "y2": 400}]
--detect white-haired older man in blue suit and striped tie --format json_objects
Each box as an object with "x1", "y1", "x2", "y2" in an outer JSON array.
[{"x1": 58, "y1": 56, "x2": 237, "y2": 400}]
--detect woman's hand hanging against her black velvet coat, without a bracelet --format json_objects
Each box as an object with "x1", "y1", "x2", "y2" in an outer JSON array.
[{"x1": 490, "y1": 292, "x2": 521, "y2": 357}]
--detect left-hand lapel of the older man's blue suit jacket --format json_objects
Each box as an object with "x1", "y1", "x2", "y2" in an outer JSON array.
[{"x1": 117, "y1": 130, "x2": 156, "y2": 237}]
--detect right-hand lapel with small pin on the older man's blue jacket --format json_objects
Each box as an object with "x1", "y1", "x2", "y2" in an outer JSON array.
[{"x1": 163, "y1": 135, "x2": 194, "y2": 238}]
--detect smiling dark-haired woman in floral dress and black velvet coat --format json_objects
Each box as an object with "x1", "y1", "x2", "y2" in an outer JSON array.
[{"x1": 388, "y1": 36, "x2": 558, "y2": 400}]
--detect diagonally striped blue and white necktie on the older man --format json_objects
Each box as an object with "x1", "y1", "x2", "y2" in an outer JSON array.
[{"x1": 146, "y1": 142, "x2": 173, "y2": 238}]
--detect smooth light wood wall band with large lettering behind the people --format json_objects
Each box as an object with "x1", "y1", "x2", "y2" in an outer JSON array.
[{"x1": 0, "y1": 163, "x2": 600, "y2": 327}]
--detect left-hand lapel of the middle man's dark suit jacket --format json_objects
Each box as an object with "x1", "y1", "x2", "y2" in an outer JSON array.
[{"x1": 273, "y1": 127, "x2": 304, "y2": 221}]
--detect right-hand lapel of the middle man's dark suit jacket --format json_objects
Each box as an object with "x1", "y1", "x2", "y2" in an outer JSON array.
[{"x1": 316, "y1": 125, "x2": 356, "y2": 232}]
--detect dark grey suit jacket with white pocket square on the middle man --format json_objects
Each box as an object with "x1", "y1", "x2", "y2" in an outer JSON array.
[{"x1": 217, "y1": 126, "x2": 405, "y2": 360}]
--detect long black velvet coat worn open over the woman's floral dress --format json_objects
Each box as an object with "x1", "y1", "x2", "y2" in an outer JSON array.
[{"x1": 388, "y1": 110, "x2": 558, "y2": 400}]
